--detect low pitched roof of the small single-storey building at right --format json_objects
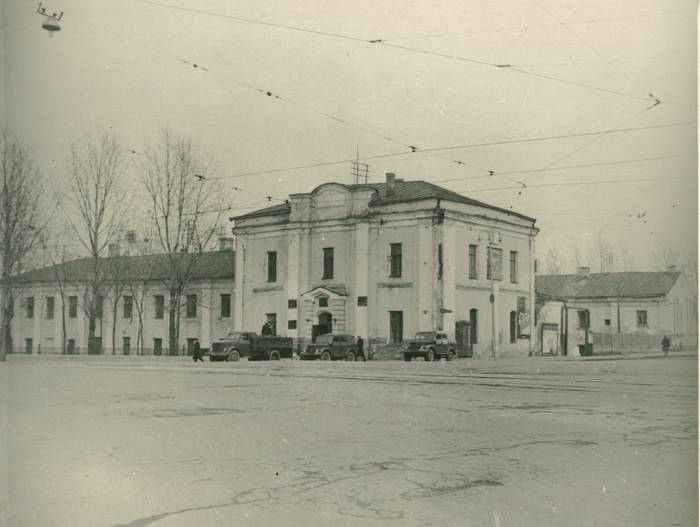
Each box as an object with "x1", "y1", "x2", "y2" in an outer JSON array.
[{"x1": 535, "y1": 271, "x2": 680, "y2": 299}]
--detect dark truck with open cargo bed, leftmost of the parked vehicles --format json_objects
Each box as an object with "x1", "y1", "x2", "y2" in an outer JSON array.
[{"x1": 209, "y1": 331, "x2": 294, "y2": 362}]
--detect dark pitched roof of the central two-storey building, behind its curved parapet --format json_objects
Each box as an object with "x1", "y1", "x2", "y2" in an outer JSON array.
[{"x1": 231, "y1": 180, "x2": 535, "y2": 222}]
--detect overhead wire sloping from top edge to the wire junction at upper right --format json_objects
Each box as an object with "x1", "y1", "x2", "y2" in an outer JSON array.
[{"x1": 131, "y1": 0, "x2": 660, "y2": 105}]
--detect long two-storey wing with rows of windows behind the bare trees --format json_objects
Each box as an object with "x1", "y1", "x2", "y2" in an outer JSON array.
[{"x1": 12, "y1": 250, "x2": 235, "y2": 355}]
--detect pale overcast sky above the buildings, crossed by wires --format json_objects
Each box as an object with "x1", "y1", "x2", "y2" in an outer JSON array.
[{"x1": 0, "y1": 0, "x2": 698, "y2": 270}]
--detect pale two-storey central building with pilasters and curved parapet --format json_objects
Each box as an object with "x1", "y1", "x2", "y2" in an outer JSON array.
[{"x1": 232, "y1": 174, "x2": 538, "y2": 355}]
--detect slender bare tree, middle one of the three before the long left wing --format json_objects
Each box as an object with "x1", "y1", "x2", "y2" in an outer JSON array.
[{"x1": 69, "y1": 133, "x2": 127, "y2": 353}]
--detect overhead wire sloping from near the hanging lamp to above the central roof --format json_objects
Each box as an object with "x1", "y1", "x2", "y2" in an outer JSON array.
[{"x1": 76, "y1": 14, "x2": 490, "y2": 177}]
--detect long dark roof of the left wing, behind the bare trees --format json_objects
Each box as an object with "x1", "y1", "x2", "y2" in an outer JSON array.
[{"x1": 16, "y1": 250, "x2": 235, "y2": 283}]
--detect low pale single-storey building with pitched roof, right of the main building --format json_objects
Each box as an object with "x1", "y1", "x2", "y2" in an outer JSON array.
[{"x1": 535, "y1": 267, "x2": 698, "y2": 355}]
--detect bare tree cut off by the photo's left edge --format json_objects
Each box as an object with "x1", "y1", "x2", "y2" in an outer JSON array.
[{"x1": 0, "y1": 128, "x2": 46, "y2": 361}]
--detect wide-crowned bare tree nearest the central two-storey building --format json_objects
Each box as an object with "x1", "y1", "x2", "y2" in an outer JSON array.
[{"x1": 141, "y1": 130, "x2": 221, "y2": 354}]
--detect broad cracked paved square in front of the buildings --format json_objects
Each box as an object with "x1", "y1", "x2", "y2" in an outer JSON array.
[{"x1": 0, "y1": 357, "x2": 698, "y2": 527}]
